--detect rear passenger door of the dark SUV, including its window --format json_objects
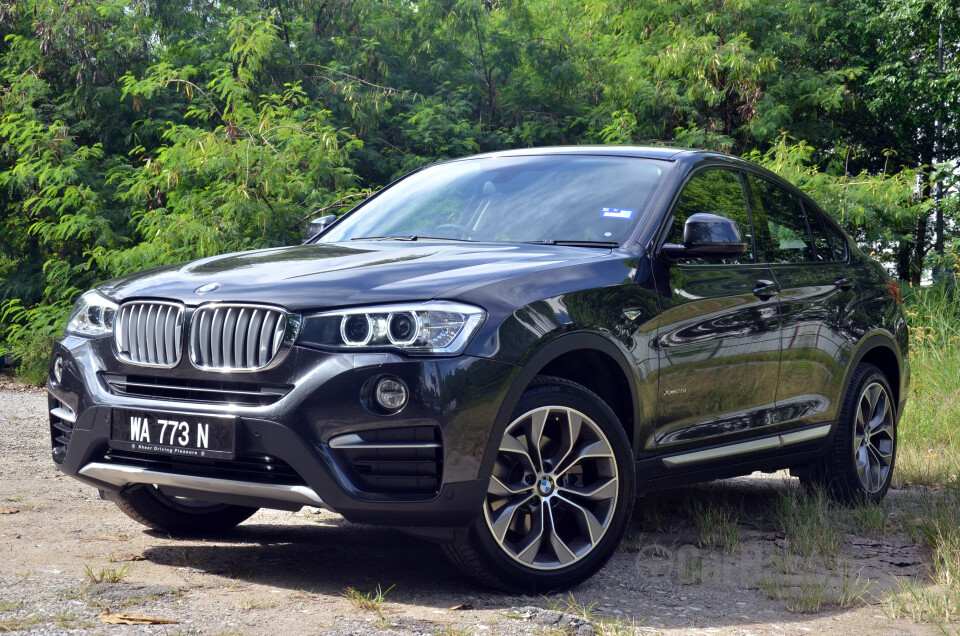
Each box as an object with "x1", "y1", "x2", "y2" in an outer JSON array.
[{"x1": 746, "y1": 174, "x2": 862, "y2": 429}]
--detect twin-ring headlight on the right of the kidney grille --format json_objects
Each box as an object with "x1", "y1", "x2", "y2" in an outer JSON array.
[{"x1": 300, "y1": 301, "x2": 486, "y2": 354}]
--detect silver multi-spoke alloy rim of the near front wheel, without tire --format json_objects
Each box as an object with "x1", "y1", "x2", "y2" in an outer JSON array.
[{"x1": 484, "y1": 406, "x2": 619, "y2": 570}]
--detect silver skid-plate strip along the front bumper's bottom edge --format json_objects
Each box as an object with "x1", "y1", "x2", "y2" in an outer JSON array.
[{"x1": 80, "y1": 462, "x2": 325, "y2": 507}]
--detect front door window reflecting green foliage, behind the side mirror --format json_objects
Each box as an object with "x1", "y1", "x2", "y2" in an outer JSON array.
[{"x1": 667, "y1": 168, "x2": 756, "y2": 265}]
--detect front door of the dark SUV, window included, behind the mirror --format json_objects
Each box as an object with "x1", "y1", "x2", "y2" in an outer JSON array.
[{"x1": 655, "y1": 167, "x2": 780, "y2": 458}]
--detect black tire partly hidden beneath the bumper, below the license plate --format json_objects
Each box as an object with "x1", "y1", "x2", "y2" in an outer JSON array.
[{"x1": 111, "y1": 485, "x2": 258, "y2": 536}]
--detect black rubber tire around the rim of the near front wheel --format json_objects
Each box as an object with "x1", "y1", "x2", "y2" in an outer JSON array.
[{"x1": 471, "y1": 380, "x2": 636, "y2": 592}]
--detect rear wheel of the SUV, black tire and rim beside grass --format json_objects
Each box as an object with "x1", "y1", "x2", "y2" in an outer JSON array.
[{"x1": 791, "y1": 364, "x2": 897, "y2": 505}]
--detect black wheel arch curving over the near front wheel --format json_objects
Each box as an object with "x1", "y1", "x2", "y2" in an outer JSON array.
[{"x1": 480, "y1": 333, "x2": 641, "y2": 479}]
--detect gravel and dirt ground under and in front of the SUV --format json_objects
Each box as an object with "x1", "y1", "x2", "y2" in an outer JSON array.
[{"x1": 0, "y1": 385, "x2": 940, "y2": 634}]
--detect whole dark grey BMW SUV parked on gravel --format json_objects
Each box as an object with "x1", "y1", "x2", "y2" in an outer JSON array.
[{"x1": 49, "y1": 147, "x2": 910, "y2": 591}]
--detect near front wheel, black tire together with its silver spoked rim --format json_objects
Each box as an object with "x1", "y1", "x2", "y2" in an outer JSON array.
[{"x1": 444, "y1": 377, "x2": 636, "y2": 594}]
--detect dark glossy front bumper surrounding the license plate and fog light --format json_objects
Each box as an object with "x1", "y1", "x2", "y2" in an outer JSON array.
[{"x1": 48, "y1": 336, "x2": 518, "y2": 528}]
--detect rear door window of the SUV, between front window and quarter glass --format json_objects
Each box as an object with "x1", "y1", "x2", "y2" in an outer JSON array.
[{"x1": 747, "y1": 175, "x2": 814, "y2": 263}]
